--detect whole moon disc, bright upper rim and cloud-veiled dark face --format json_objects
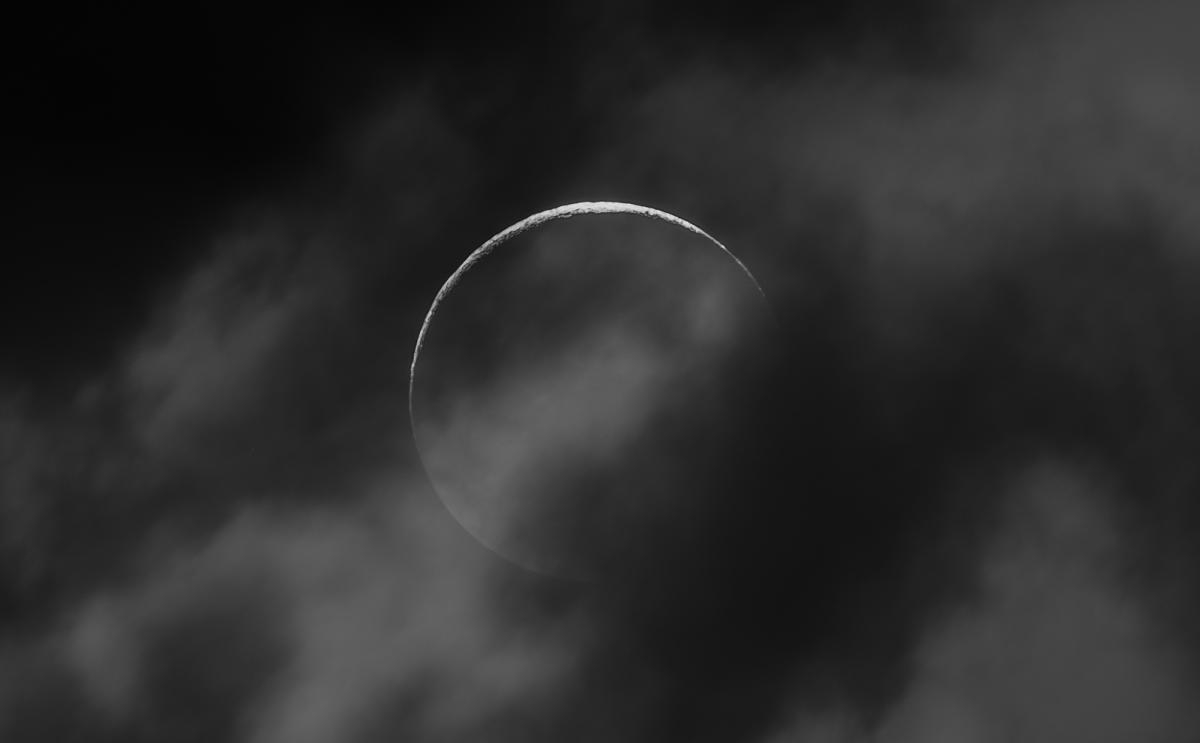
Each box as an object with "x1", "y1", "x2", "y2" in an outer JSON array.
[{"x1": 409, "y1": 202, "x2": 770, "y2": 579}]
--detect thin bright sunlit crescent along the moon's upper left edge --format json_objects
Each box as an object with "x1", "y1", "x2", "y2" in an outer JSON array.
[{"x1": 408, "y1": 202, "x2": 766, "y2": 573}]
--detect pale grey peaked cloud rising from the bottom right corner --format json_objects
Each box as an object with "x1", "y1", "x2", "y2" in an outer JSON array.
[{"x1": 769, "y1": 461, "x2": 1200, "y2": 743}]
